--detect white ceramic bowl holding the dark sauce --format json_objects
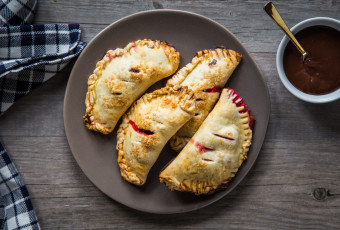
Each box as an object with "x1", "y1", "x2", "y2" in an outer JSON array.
[{"x1": 276, "y1": 17, "x2": 340, "y2": 103}]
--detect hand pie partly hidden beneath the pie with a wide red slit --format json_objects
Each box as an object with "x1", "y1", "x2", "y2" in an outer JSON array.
[{"x1": 167, "y1": 48, "x2": 242, "y2": 152}]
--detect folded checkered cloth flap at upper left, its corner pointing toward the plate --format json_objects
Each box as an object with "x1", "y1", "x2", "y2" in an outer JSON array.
[{"x1": 0, "y1": 24, "x2": 85, "y2": 115}]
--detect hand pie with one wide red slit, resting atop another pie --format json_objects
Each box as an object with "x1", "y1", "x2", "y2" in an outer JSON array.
[{"x1": 117, "y1": 86, "x2": 195, "y2": 185}]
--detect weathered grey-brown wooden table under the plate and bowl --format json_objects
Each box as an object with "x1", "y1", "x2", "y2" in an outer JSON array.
[{"x1": 0, "y1": 0, "x2": 340, "y2": 229}]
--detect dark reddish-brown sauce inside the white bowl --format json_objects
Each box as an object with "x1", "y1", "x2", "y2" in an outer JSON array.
[{"x1": 283, "y1": 26, "x2": 340, "y2": 95}]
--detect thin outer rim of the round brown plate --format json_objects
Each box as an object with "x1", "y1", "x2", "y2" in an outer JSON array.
[{"x1": 63, "y1": 9, "x2": 271, "y2": 215}]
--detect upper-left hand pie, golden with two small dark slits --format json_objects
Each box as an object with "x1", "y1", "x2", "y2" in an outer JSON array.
[{"x1": 84, "y1": 40, "x2": 179, "y2": 134}]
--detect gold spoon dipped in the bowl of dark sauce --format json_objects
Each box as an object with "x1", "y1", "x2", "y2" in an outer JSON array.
[{"x1": 263, "y1": 2, "x2": 308, "y2": 61}]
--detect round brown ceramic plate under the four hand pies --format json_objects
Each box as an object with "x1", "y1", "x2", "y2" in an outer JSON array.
[{"x1": 64, "y1": 10, "x2": 270, "y2": 213}]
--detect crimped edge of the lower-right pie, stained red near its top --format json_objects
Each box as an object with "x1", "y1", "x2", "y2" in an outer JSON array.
[{"x1": 160, "y1": 88, "x2": 252, "y2": 195}]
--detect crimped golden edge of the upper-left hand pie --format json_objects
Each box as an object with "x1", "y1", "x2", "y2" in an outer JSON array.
[{"x1": 83, "y1": 39, "x2": 179, "y2": 134}]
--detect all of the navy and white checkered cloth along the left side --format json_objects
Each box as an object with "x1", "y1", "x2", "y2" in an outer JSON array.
[{"x1": 0, "y1": 0, "x2": 86, "y2": 229}]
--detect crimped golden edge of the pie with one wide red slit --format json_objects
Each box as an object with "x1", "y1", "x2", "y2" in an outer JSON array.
[{"x1": 116, "y1": 86, "x2": 194, "y2": 185}]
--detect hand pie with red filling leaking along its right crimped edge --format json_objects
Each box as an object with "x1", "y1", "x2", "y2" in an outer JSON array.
[{"x1": 160, "y1": 89, "x2": 254, "y2": 195}]
